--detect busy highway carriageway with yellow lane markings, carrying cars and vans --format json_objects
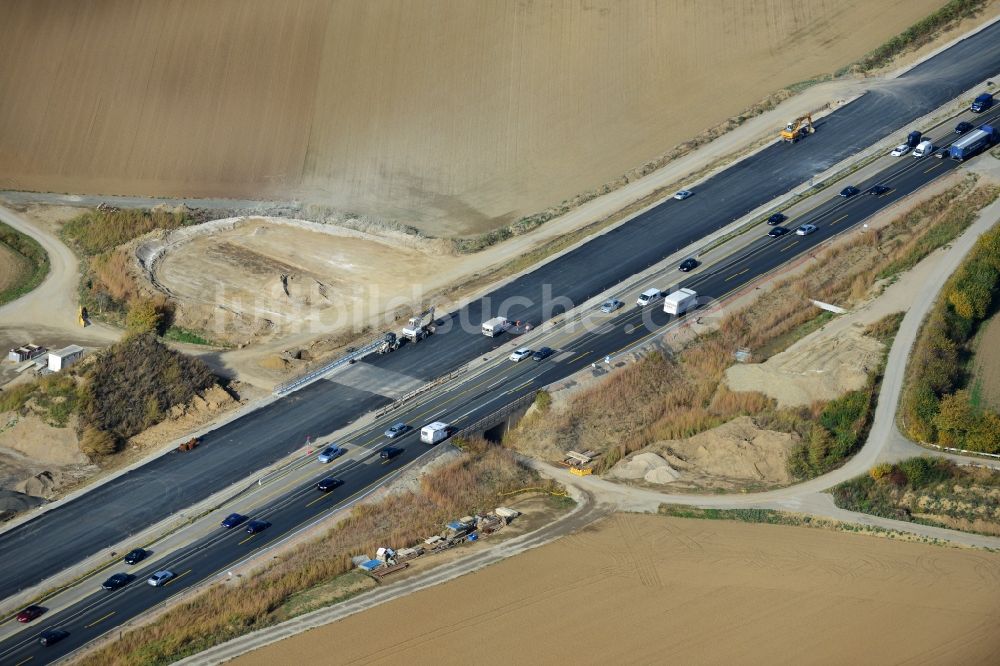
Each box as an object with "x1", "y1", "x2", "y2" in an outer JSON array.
[{"x1": 0, "y1": 93, "x2": 1000, "y2": 664}]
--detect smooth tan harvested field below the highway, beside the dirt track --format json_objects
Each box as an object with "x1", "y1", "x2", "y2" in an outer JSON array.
[{"x1": 231, "y1": 515, "x2": 1000, "y2": 666}]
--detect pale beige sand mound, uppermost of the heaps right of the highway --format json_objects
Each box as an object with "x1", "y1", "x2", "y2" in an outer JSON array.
[{"x1": 726, "y1": 328, "x2": 883, "y2": 407}]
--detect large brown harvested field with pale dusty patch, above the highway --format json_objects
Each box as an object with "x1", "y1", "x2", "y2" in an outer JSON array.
[{"x1": 0, "y1": 0, "x2": 941, "y2": 235}]
